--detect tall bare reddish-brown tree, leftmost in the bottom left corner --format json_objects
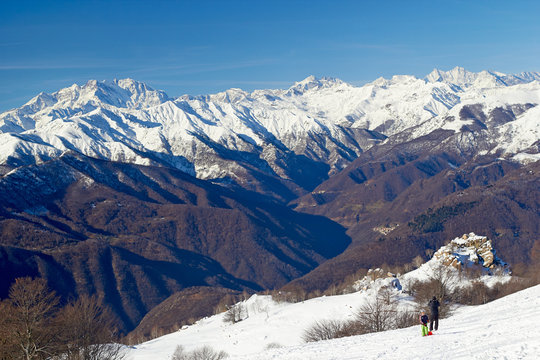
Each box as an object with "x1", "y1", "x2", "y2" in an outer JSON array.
[{"x1": 3, "y1": 277, "x2": 59, "y2": 360}]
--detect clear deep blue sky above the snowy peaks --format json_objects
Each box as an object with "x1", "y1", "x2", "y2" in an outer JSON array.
[{"x1": 0, "y1": 0, "x2": 540, "y2": 111}]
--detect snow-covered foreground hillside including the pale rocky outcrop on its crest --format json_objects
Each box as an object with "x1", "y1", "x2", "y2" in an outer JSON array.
[{"x1": 128, "y1": 233, "x2": 540, "y2": 360}]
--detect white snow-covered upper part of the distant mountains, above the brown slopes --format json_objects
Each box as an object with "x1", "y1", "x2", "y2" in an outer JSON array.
[{"x1": 0, "y1": 67, "x2": 540, "y2": 188}]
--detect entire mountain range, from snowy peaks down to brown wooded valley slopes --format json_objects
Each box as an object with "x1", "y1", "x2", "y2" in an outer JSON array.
[{"x1": 0, "y1": 67, "x2": 540, "y2": 331}]
